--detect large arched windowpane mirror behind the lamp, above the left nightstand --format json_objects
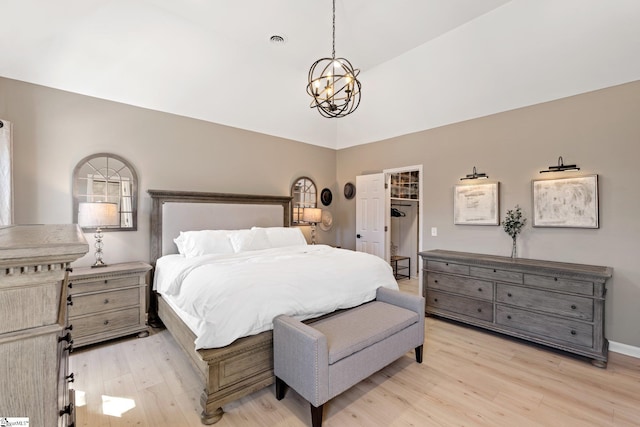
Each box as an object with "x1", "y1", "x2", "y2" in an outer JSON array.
[{"x1": 73, "y1": 153, "x2": 138, "y2": 231}]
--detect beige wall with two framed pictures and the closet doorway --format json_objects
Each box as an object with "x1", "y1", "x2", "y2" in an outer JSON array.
[{"x1": 335, "y1": 82, "x2": 640, "y2": 347}]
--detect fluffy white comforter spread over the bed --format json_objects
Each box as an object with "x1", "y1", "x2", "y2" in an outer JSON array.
[{"x1": 154, "y1": 245, "x2": 398, "y2": 348}]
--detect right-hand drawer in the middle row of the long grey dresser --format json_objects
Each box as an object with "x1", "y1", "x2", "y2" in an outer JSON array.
[{"x1": 496, "y1": 283, "x2": 593, "y2": 321}]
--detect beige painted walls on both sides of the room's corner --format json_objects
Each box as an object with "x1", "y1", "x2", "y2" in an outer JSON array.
[{"x1": 0, "y1": 78, "x2": 640, "y2": 347}]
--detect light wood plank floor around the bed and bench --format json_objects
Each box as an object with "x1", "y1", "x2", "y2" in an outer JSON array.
[{"x1": 70, "y1": 280, "x2": 640, "y2": 427}]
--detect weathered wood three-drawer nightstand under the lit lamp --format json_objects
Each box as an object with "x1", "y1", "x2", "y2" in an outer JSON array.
[{"x1": 67, "y1": 262, "x2": 151, "y2": 347}]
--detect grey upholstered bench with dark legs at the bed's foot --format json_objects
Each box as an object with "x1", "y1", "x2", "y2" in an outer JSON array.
[{"x1": 273, "y1": 288, "x2": 424, "y2": 427}]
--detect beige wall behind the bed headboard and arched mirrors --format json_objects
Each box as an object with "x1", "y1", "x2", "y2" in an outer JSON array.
[{"x1": 0, "y1": 78, "x2": 337, "y2": 265}]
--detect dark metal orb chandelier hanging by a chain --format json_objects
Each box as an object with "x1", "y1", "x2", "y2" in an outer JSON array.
[{"x1": 307, "y1": 0, "x2": 360, "y2": 118}]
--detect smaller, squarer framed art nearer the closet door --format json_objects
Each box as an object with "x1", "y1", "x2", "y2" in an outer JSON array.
[{"x1": 453, "y1": 182, "x2": 500, "y2": 225}]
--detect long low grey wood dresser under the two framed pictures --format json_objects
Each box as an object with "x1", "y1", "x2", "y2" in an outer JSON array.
[{"x1": 420, "y1": 250, "x2": 613, "y2": 368}]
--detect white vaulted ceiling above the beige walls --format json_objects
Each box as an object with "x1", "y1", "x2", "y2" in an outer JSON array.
[{"x1": 0, "y1": 0, "x2": 640, "y2": 149}]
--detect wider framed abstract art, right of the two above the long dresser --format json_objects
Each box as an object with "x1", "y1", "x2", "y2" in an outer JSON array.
[{"x1": 532, "y1": 175, "x2": 599, "y2": 228}]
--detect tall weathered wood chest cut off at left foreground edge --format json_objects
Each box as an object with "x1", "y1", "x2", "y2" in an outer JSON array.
[{"x1": 0, "y1": 224, "x2": 89, "y2": 427}]
